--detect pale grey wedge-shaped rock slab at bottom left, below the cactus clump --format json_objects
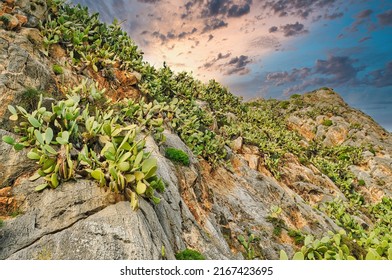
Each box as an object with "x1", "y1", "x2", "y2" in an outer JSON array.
[{"x1": 8, "y1": 201, "x2": 174, "y2": 260}]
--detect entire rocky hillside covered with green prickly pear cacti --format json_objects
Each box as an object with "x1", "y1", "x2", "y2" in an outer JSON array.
[{"x1": 0, "y1": 0, "x2": 392, "y2": 259}]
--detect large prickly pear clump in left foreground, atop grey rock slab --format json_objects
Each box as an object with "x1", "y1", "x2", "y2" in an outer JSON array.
[{"x1": 3, "y1": 89, "x2": 164, "y2": 209}]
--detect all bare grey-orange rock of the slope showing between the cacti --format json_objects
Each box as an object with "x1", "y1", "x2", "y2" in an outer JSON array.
[{"x1": 0, "y1": 0, "x2": 392, "y2": 259}]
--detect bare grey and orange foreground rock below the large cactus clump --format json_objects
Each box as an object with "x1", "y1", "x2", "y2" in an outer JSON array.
[{"x1": 0, "y1": 132, "x2": 337, "y2": 259}]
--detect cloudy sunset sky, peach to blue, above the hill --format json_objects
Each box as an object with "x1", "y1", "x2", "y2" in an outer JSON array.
[{"x1": 72, "y1": 0, "x2": 392, "y2": 131}]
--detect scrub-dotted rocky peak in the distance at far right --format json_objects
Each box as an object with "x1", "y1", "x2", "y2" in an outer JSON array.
[{"x1": 285, "y1": 89, "x2": 392, "y2": 202}]
